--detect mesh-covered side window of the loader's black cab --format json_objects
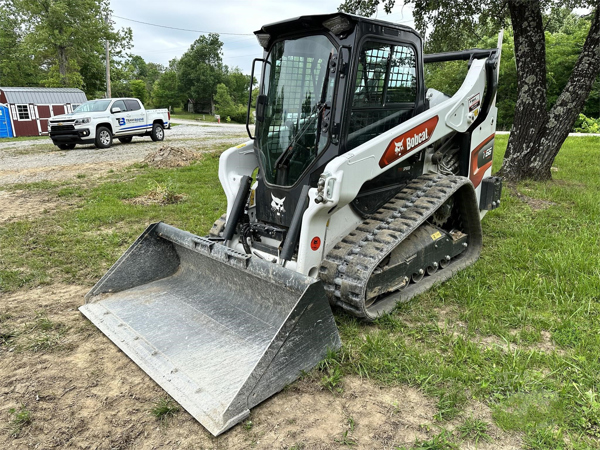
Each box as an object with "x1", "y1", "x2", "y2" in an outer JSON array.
[{"x1": 346, "y1": 41, "x2": 417, "y2": 151}]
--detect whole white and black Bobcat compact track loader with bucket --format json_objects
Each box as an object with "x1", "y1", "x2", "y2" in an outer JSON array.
[{"x1": 80, "y1": 13, "x2": 502, "y2": 435}]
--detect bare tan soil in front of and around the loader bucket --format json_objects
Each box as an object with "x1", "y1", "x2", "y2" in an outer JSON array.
[{"x1": 0, "y1": 285, "x2": 519, "y2": 449}]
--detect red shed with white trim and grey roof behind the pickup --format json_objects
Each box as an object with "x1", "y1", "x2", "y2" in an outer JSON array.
[{"x1": 0, "y1": 87, "x2": 87, "y2": 137}]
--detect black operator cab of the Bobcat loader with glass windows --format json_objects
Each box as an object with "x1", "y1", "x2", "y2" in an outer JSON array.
[{"x1": 251, "y1": 13, "x2": 425, "y2": 233}]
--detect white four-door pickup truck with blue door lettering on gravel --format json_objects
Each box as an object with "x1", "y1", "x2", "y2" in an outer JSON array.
[{"x1": 48, "y1": 98, "x2": 171, "y2": 150}]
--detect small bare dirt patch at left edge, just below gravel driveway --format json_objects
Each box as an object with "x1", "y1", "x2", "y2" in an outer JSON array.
[{"x1": 0, "y1": 190, "x2": 70, "y2": 223}]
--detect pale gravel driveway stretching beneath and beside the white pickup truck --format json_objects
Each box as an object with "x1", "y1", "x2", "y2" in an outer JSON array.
[{"x1": 0, "y1": 120, "x2": 248, "y2": 186}]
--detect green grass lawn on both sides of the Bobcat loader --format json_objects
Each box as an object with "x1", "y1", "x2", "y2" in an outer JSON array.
[{"x1": 0, "y1": 135, "x2": 600, "y2": 449}]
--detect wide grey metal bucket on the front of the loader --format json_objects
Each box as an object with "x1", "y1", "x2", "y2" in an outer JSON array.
[{"x1": 80, "y1": 223, "x2": 340, "y2": 436}]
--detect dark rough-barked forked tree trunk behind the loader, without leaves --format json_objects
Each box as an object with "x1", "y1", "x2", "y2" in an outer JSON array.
[{"x1": 501, "y1": 0, "x2": 600, "y2": 181}]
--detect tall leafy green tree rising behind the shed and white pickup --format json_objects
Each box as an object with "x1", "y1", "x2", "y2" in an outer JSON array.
[{"x1": 13, "y1": 0, "x2": 131, "y2": 92}]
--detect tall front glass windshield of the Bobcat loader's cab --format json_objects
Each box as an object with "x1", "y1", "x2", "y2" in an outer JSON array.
[{"x1": 256, "y1": 35, "x2": 337, "y2": 186}]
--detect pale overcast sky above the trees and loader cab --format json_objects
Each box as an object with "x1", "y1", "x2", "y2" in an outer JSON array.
[{"x1": 111, "y1": 0, "x2": 414, "y2": 73}]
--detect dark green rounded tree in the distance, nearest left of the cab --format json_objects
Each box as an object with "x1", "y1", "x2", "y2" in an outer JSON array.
[{"x1": 177, "y1": 33, "x2": 223, "y2": 112}]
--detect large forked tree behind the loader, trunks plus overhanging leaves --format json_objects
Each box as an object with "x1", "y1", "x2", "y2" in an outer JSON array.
[{"x1": 340, "y1": 0, "x2": 600, "y2": 181}]
